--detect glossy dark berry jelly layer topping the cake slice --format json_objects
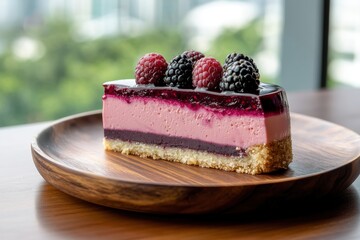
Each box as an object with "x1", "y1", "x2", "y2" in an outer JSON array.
[{"x1": 104, "y1": 81, "x2": 288, "y2": 115}]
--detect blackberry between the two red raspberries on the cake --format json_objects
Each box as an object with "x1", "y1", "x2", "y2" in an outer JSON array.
[{"x1": 164, "y1": 55, "x2": 193, "y2": 88}]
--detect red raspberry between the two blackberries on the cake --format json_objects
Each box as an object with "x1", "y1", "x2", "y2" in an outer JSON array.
[{"x1": 192, "y1": 57, "x2": 223, "y2": 90}]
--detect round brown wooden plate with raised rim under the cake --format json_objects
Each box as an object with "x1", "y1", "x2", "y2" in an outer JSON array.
[{"x1": 31, "y1": 111, "x2": 360, "y2": 214}]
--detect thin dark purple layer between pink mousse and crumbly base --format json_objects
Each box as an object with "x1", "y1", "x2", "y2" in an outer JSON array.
[{"x1": 104, "y1": 129, "x2": 246, "y2": 156}]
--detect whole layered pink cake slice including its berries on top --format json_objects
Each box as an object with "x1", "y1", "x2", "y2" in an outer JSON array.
[{"x1": 103, "y1": 51, "x2": 292, "y2": 174}]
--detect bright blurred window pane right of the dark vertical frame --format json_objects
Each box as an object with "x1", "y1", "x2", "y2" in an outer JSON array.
[{"x1": 328, "y1": 0, "x2": 360, "y2": 88}]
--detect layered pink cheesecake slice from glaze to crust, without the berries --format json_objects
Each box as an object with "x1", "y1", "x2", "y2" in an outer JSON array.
[{"x1": 103, "y1": 80, "x2": 292, "y2": 174}]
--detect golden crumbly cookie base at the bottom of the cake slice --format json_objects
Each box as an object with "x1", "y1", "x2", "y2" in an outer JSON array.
[{"x1": 104, "y1": 136, "x2": 292, "y2": 175}]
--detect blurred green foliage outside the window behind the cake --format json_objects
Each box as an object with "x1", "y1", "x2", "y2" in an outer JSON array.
[{"x1": 0, "y1": 20, "x2": 261, "y2": 126}]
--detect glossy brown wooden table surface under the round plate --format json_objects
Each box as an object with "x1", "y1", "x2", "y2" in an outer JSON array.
[{"x1": 0, "y1": 89, "x2": 360, "y2": 239}]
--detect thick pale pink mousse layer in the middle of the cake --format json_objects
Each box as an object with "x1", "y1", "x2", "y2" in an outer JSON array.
[{"x1": 103, "y1": 95, "x2": 290, "y2": 148}]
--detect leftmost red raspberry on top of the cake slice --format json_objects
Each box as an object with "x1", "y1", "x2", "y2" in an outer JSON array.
[{"x1": 135, "y1": 53, "x2": 168, "y2": 86}]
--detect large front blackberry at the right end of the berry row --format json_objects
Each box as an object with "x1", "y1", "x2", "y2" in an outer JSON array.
[{"x1": 220, "y1": 59, "x2": 260, "y2": 94}]
